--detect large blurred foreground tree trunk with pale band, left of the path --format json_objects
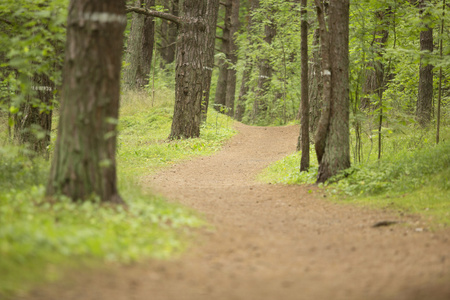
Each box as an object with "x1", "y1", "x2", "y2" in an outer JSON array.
[{"x1": 47, "y1": 0, "x2": 126, "y2": 203}]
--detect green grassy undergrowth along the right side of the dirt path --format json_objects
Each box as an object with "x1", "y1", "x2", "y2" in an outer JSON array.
[{"x1": 259, "y1": 129, "x2": 450, "y2": 226}]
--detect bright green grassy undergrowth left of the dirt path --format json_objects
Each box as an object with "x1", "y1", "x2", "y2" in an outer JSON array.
[{"x1": 0, "y1": 90, "x2": 234, "y2": 299}]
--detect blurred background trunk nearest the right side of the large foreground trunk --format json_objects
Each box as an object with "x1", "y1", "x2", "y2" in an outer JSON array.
[{"x1": 124, "y1": 0, "x2": 155, "y2": 88}]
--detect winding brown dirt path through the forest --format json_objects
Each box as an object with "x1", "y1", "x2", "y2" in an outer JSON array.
[{"x1": 20, "y1": 124, "x2": 450, "y2": 300}]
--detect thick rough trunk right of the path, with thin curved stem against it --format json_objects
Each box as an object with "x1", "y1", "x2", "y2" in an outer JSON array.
[{"x1": 317, "y1": 0, "x2": 350, "y2": 182}]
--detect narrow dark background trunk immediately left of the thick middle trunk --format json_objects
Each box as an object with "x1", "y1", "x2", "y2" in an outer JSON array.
[{"x1": 160, "y1": 0, "x2": 179, "y2": 68}]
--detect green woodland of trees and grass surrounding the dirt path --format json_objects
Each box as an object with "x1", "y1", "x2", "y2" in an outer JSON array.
[{"x1": 0, "y1": 0, "x2": 450, "y2": 296}]
